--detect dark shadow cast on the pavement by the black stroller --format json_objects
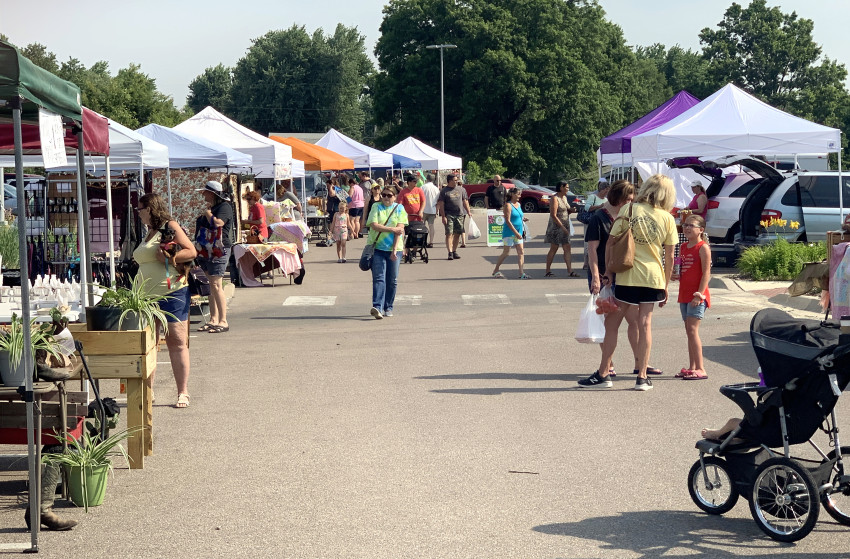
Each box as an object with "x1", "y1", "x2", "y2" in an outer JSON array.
[{"x1": 533, "y1": 503, "x2": 843, "y2": 559}]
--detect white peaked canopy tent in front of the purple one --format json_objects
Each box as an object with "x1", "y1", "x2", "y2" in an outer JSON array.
[{"x1": 632, "y1": 84, "x2": 844, "y2": 214}]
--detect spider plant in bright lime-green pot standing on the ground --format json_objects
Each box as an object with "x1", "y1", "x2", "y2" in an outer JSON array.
[{"x1": 41, "y1": 429, "x2": 138, "y2": 512}]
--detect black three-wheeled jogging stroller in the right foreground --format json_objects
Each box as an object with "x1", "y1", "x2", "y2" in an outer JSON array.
[{"x1": 688, "y1": 309, "x2": 850, "y2": 542}]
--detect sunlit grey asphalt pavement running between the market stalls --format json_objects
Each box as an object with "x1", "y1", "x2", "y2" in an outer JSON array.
[{"x1": 0, "y1": 214, "x2": 850, "y2": 559}]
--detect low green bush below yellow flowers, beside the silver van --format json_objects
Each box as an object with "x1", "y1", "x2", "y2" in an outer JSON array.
[{"x1": 738, "y1": 238, "x2": 826, "y2": 280}]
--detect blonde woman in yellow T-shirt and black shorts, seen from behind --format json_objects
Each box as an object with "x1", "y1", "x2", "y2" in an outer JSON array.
[{"x1": 579, "y1": 175, "x2": 679, "y2": 391}]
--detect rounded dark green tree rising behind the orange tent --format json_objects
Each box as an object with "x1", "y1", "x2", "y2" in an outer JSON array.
[{"x1": 224, "y1": 24, "x2": 373, "y2": 138}]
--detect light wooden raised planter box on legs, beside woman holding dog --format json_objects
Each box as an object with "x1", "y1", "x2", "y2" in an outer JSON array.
[{"x1": 68, "y1": 324, "x2": 157, "y2": 469}]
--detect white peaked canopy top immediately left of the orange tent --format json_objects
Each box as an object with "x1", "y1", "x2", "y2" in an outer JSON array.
[{"x1": 174, "y1": 107, "x2": 292, "y2": 180}]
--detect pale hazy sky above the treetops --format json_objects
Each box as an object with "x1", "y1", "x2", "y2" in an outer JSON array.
[{"x1": 0, "y1": 0, "x2": 850, "y2": 107}]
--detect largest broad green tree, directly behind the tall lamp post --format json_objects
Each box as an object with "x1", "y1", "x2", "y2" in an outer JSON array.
[{"x1": 373, "y1": 0, "x2": 669, "y2": 181}]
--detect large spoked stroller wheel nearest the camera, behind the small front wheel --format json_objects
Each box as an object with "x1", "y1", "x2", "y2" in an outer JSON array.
[{"x1": 750, "y1": 456, "x2": 820, "y2": 542}]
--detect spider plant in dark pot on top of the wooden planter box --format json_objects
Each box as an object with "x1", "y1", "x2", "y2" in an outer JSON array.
[{"x1": 86, "y1": 276, "x2": 174, "y2": 330}]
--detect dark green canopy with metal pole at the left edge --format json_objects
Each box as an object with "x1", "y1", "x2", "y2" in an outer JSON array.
[{"x1": 0, "y1": 41, "x2": 84, "y2": 552}]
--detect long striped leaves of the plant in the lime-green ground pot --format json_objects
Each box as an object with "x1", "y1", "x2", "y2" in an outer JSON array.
[{"x1": 41, "y1": 427, "x2": 142, "y2": 512}]
